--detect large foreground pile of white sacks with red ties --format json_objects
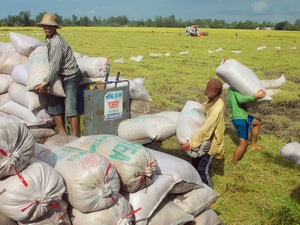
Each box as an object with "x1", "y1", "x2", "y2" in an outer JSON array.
[{"x1": 0, "y1": 114, "x2": 222, "y2": 225}]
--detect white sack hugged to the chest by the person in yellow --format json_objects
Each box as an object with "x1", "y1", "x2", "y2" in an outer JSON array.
[{"x1": 176, "y1": 101, "x2": 206, "y2": 142}]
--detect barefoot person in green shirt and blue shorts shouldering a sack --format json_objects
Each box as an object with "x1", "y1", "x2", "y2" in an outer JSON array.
[{"x1": 228, "y1": 87, "x2": 266, "y2": 164}]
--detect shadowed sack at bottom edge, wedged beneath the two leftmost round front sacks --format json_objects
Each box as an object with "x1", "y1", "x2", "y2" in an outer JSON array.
[{"x1": 18, "y1": 199, "x2": 72, "y2": 225}]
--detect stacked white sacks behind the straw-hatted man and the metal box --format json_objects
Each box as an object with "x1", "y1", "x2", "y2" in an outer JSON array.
[{"x1": 0, "y1": 32, "x2": 152, "y2": 138}]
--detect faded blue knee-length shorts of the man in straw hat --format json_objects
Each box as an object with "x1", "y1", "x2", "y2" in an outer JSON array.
[{"x1": 47, "y1": 71, "x2": 82, "y2": 117}]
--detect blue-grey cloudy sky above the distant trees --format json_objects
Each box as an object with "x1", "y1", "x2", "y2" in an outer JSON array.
[{"x1": 0, "y1": 0, "x2": 300, "y2": 24}]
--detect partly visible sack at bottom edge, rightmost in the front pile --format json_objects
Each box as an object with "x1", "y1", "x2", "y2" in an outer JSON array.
[{"x1": 189, "y1": 208, "x2": 224, "y2": 225}]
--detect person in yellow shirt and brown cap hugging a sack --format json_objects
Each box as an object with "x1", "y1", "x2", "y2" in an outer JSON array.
[{"x1": 180, "y1": 79, "x2": 225, "y2": 187}]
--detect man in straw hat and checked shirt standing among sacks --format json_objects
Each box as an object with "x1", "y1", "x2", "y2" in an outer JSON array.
[{"x1": 36, "y1": 13, "x2": 82, "y2": 136}]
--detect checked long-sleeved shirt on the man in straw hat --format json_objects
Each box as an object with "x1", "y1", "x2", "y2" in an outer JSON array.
[{"x1": 43, "y1": 33, "x2": 79, "y2": 85}]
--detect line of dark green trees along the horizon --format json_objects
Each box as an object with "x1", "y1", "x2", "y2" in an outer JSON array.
[{"x1": 0, "y1": 11, "x2": 300, "y2": 30}]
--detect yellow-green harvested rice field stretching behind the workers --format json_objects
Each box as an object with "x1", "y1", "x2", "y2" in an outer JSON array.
[{"x1": 0, "y1": 27, "x2": 300, "y2": 225}]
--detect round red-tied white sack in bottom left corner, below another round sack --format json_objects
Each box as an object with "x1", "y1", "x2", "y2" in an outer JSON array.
[{"x1": 0, "y1": 160, "x2": 66, "y2": 223}]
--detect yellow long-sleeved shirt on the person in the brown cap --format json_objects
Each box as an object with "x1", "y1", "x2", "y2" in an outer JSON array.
[{"x1": 190, "y1": 98, "x2": 225, "y2": 159}]
